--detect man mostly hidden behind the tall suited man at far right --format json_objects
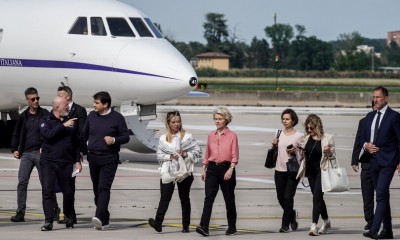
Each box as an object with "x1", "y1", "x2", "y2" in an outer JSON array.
[{"x1": 351, "y1": 101, "x2": 375, "y2": 230}]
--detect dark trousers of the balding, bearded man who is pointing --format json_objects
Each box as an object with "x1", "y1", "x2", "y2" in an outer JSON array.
[{"x1": 40, "y1": 160, "x2": 74, "y2": 223}]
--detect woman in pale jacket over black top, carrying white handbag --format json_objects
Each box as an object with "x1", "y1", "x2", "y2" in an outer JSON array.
[{"x1": 297, "y1": 114, "x2": 336, "y2": 236}]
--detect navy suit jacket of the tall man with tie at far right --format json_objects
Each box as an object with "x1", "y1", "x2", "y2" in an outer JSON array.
[{"x1": 361, "y1": 107, "x2": 400, "y2": 167}]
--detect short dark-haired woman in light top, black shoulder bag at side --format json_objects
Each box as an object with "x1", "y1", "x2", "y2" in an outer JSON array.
[{"x1": 272, "y1": 108, "x2": 303, "y2": 233}]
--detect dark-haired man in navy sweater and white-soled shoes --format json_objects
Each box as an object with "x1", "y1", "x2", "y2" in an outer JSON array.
[{"x1": 81, "y1": 92, "x2": 129, "y2": 230}]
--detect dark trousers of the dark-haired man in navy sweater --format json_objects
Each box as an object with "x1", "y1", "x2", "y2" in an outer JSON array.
[{"x1": 88, "y1": 153, "x2": 119, "y2": 226}]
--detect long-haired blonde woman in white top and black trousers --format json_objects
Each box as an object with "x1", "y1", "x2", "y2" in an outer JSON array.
[{"x1": 149, "y1": 111, "x2": 202, "y2": 233}]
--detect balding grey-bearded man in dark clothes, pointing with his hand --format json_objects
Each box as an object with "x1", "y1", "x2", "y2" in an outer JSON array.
[{"x1": 40, "y1": 96, "x2": 82, "y2": 231}]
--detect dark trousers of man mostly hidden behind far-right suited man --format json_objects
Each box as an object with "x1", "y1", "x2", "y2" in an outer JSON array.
[{"x1": 360, "y1": 166, "x2": 375, "y2": 226}]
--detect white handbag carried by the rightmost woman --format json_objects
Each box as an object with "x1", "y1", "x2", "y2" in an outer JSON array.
[{"x1": 321, "y1": 160, "x2": 350, "y2": 192}]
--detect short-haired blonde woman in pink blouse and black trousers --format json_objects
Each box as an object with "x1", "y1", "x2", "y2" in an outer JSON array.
[{"x1": 196, "y1": 107, "x2": 239, "y2": 236}]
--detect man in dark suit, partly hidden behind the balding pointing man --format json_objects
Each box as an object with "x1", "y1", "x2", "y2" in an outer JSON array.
[{"x1": 57, "y1": 86, "x2": 87, "y2": 224}]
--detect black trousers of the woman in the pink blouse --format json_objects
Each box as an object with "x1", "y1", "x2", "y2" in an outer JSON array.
[{"x1": 200, "y1": 162, "x2": 237, "y2": 229}]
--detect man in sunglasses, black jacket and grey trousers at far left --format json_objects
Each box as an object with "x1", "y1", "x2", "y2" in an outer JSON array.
[{"x1": 11, "y1": 87, "x2": 49, "y2": 222}]
